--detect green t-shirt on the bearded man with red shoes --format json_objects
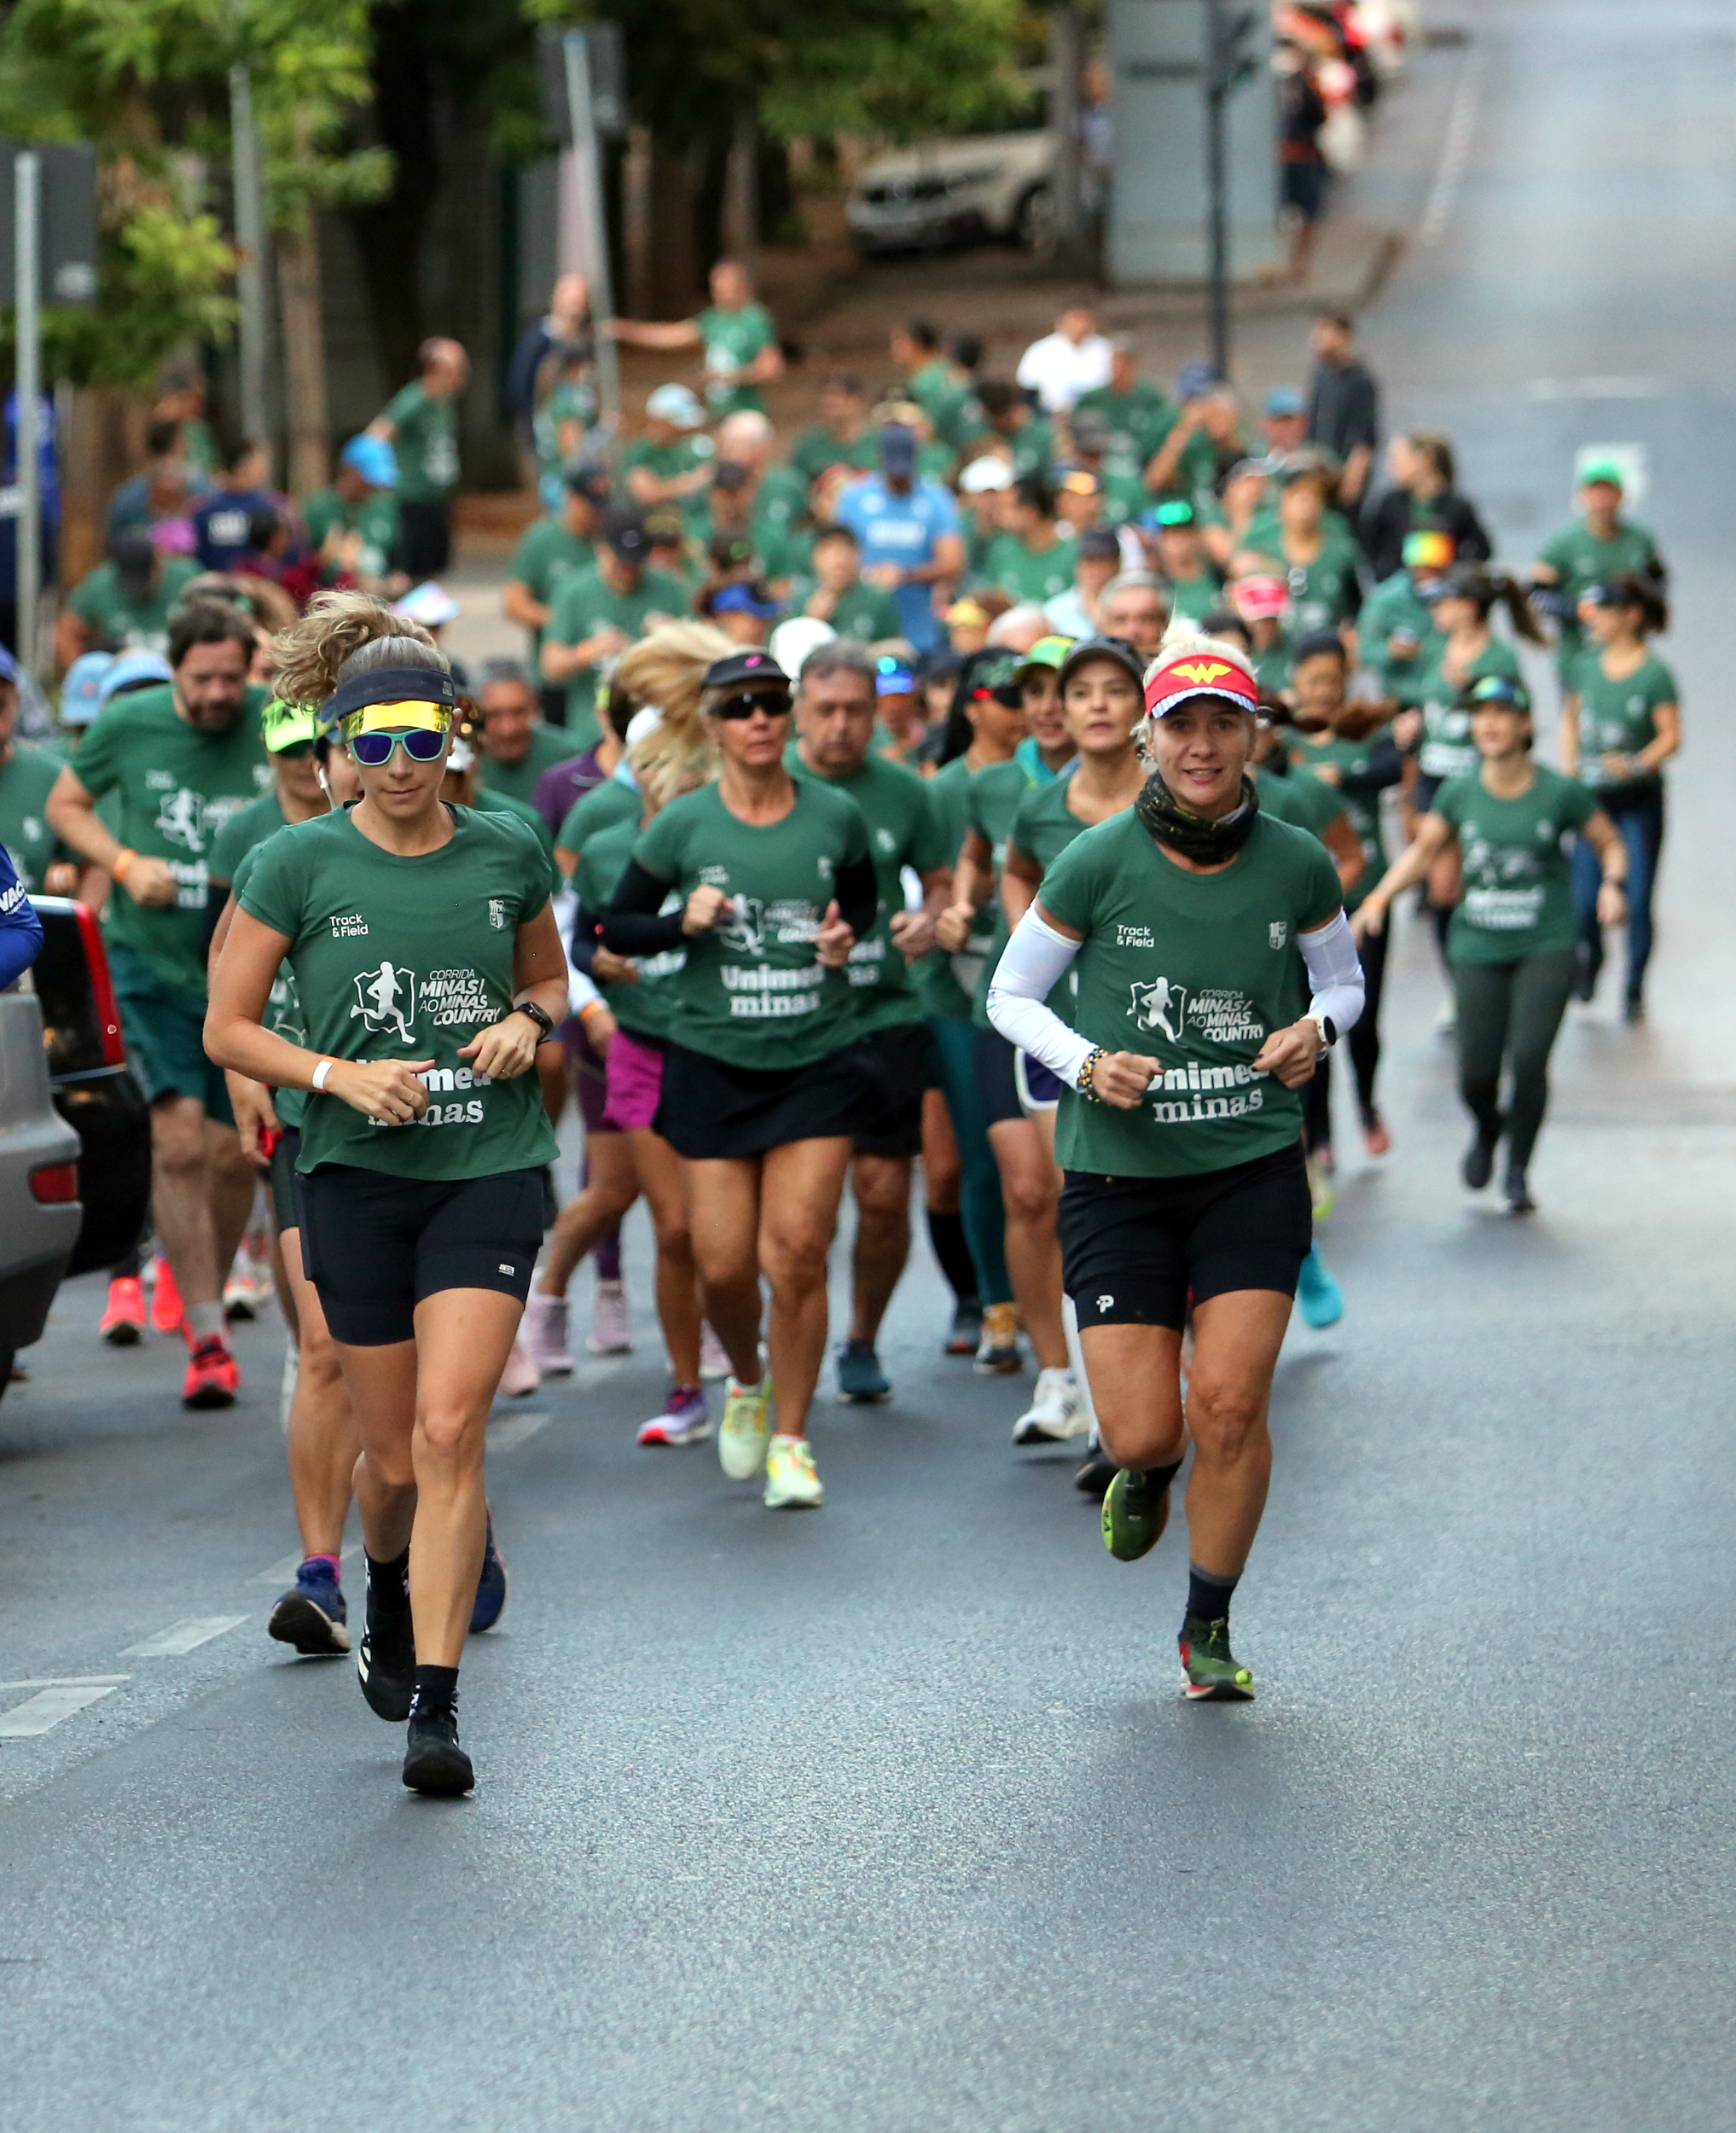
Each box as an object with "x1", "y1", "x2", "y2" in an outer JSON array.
[{"x1": 75, "y1": 683, "x2": 273, "y2": 998}]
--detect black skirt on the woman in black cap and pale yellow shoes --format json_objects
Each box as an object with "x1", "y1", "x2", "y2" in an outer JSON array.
[{"x1": 657, "y1": 1043, "x2": 879, "y2": 1163}]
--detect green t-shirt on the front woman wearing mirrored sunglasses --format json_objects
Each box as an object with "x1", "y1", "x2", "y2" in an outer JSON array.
[{"x1": 241, "y1": 806, "x2": 557, "y2": 1180}]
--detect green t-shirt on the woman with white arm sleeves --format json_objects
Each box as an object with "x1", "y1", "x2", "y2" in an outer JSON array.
[{"x1": 1041, "y1": 811, "x2": 1342, "y2": 1177}]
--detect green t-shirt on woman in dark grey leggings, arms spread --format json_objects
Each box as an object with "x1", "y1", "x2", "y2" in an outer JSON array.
[{"x1": 1433, "y1": 764, "x2": 1598, "y2": 962}]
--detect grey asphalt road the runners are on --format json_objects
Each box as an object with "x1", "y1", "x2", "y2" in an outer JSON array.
[{"x1": 0, "y1": 0, "x2": 1736, "y2": 2133}]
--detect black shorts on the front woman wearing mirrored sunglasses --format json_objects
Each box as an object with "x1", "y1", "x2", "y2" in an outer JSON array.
[{"x1": 297, "y1": 1163, "x2": 544, "y2": 1348}]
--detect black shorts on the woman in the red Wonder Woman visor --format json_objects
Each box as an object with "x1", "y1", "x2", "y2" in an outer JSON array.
[{"x1": 1056, "y1": 1142, "x2": 1314, "y2": 1334}]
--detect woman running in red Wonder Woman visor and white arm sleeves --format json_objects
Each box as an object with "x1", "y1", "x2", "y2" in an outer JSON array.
[{"x1": 990, "y1": 638, "x2": 1361, "y2": 1700}]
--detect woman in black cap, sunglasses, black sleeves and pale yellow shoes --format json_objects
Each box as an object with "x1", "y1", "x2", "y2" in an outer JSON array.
[{"x1": 604, "y1": 648, "x2": 879, "y2": 1510}]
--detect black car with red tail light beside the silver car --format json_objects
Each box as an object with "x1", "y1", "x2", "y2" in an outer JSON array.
[{"x1": 30, "y1": 896, "x2": 152, "y2": 1274}]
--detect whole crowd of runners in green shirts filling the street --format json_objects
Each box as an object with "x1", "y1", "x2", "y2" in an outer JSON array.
[{"x1": 0, "y1": 279, "x2": 1681, "y2": 1792}]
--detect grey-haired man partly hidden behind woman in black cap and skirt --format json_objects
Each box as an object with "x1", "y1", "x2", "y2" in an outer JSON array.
[{"x1": 785, "y1": 640, "x2": 951, "y2": 1406}]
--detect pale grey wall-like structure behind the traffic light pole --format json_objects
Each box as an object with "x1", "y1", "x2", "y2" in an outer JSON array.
[{"x1": 1107, "y1": 0, "x2": 1280, "y2": 286}]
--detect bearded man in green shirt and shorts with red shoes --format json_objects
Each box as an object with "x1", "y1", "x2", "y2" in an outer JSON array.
[{"x1": 47, "y1": 606, "x2": 271, "y2": 1408}]
